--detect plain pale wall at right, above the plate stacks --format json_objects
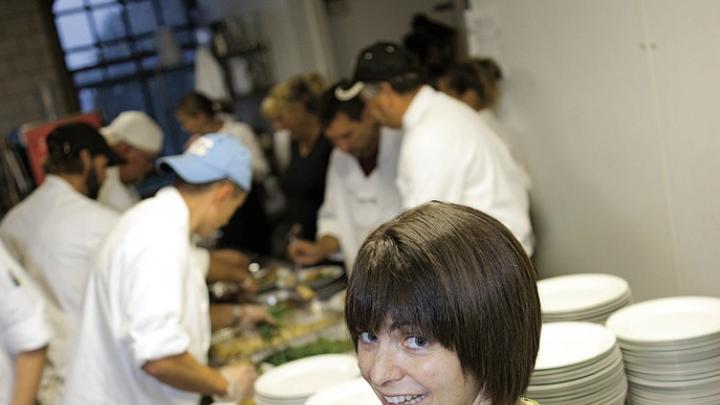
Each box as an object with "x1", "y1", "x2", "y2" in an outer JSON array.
[{"x1": 472, "y1": 0, "x2": 720, "y2": 299}]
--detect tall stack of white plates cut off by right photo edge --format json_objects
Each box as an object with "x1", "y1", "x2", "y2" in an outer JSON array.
[{"x1": 607, "y1": 297, "x2": 720, "y2": 405}]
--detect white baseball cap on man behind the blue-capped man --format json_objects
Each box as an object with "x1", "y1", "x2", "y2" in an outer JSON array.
[{"x1": 100, "y1": 111, "x2": 163, "y2": 154}]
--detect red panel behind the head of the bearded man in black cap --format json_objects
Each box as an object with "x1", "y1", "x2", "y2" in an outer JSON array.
[{"x1": 23, "y1": 112, "x2": 102, "y2": 185}]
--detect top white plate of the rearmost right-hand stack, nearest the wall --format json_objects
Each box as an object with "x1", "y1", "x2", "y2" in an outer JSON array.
[{"x1": 538, "y1": 273, "x2": 630, "y2": 314}]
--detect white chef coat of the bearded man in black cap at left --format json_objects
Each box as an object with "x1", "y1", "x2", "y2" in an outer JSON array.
[{"x1": 0, "y1": 175, "x2": 118, "y2": 397}]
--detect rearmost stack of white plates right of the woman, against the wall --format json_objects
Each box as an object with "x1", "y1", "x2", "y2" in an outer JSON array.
[{"x1": 538, "y1": 273, "x2": 632, "y2": 324}]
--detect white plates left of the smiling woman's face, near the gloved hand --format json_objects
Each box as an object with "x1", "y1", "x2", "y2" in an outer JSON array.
[{"x1": 255, "y1": 354, "x2": 360, "y2": 405}]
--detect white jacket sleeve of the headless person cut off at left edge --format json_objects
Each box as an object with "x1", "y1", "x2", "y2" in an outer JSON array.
[{"x1": 0, "y1": 246, "x2": 50, "y2": 354}]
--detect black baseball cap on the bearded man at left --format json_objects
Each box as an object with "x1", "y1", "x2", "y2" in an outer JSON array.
[{"x1": 45, "y1": 122, "x2": 125, "y2": 166}]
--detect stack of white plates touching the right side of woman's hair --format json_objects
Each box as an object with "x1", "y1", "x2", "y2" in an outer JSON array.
[{"x1": 527, "y1": 322, "x2": 627, "y2": 405}]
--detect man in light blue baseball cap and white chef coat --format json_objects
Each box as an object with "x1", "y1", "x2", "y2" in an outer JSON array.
[{"x1": 61, "y1": 134, "x2": 270, "y2": 405}]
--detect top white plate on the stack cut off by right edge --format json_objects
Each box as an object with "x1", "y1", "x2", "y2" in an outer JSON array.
[{"x1": 607, "y1": 297, "x2": 720, "y2": 344}]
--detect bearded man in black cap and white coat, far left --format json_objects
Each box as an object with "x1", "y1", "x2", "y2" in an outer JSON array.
[{"x1": 0, "y1": 120, "x2": 122, "y2": 403}]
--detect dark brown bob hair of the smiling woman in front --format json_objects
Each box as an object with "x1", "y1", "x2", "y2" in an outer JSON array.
[{"x1": 345, "y1": 201, "x2": 541, "y2": 405}]
